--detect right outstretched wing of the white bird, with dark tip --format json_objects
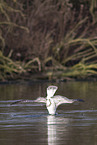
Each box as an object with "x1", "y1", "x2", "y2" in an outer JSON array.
[{"x1": 54, "y1": 95, "x2": 84, "y2": 107}]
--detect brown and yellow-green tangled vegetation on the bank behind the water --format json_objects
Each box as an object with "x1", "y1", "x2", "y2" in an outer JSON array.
[{"x1": 0, "y1": 0, "x2": 97, "y2": 81}]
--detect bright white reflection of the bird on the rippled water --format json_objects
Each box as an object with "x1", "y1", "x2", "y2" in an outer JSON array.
[{"x1": 47, "y1": 115, "x2": 69, "y2": 145}]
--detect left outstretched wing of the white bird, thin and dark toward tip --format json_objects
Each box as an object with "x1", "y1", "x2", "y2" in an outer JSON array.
[{"x1": 11, "y1": 97, "x2": 46, "y2": 105}]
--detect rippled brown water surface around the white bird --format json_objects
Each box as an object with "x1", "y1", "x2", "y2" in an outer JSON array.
[{"x1": 0, "y1": 82, "x2": 97, "y2": 145}]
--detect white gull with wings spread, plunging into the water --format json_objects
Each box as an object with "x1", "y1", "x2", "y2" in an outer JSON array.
[{"x1": 11, "y1": 86, "x2": 84, "y2": 115}]
